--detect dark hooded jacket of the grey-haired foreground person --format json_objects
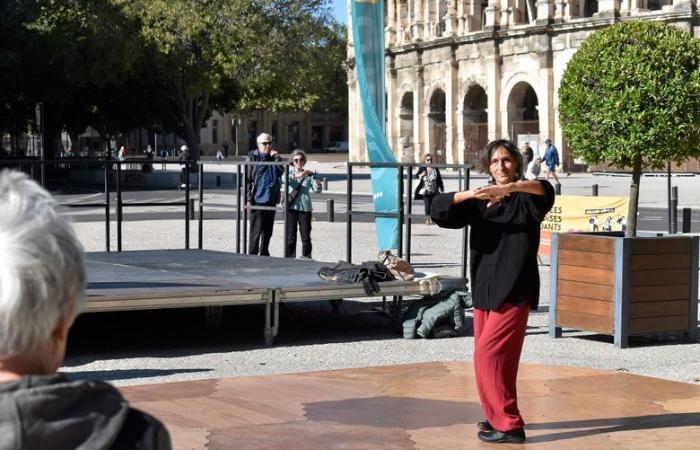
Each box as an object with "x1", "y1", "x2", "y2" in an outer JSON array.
[{"x1": 0, "y1": 374, "x2": 171, "y2": 450}]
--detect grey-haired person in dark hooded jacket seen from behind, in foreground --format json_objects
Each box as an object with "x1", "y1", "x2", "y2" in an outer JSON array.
[{"x1": 0, "y1": 171, "x2": 171, "y2": 450}]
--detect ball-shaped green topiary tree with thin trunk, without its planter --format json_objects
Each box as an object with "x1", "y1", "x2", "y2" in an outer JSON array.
[{"x1": 559, "y1": 21, "x2": 700, "y2": 236}]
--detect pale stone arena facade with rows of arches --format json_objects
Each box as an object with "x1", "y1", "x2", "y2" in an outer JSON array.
[{"x1": 348, "y1": 0, "x2": 700, "y2": 171}]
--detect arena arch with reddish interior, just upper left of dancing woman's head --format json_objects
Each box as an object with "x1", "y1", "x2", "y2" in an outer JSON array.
[{"x1": 462, "y1": 84, "x2": 489, "y2": 164}]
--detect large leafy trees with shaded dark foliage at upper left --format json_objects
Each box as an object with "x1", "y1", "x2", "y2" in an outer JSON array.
[{"x1": 0, "y1": 0, "x2": 347, "y2": 156}]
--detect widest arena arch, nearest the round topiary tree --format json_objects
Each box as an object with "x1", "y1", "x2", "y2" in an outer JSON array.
[{"x1": 508, "y1": 81, "x2": 540, "y2": 151}]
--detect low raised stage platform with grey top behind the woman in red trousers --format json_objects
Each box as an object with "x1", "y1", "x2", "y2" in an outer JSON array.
[{"x1": 85, "y1": 250, "x2": 466, "y2": 344}]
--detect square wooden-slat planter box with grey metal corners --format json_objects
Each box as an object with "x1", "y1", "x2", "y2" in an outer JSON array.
[{"x1": 549, "y1": 233, "x2": 698, "y2": 348}]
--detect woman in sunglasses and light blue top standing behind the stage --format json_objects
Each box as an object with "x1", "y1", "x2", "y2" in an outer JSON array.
[{"x1": 284, "y1": 149, "x2": 322, "y2": 259}]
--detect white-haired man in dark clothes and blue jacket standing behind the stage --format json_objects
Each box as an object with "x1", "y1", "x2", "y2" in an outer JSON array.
[{"x1": 246, "y1": 133, "x2": 284, "y2": 256}]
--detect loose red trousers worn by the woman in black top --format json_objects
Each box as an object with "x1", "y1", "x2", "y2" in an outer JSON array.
[{"x1": 474, "y1": 302, "x2": 530, "y2": 432}]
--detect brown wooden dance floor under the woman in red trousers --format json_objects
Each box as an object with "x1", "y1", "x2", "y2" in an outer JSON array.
[{"x1": 121, "y1": 362, "x2": 700, "y2": 450}]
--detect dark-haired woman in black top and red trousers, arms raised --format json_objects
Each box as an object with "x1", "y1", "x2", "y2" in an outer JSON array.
[{"x1": 432, "y1": 139, "x2": 554, "y2": 443}]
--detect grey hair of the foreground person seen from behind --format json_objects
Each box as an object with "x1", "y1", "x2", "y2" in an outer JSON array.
[{"x1": 0, "y1": 171, "x2": 85, "y2": 357}]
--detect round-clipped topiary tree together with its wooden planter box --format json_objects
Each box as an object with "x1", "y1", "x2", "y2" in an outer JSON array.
[{"x1": 550, "y1": 21, "x2": 700, "y2": 347}]
